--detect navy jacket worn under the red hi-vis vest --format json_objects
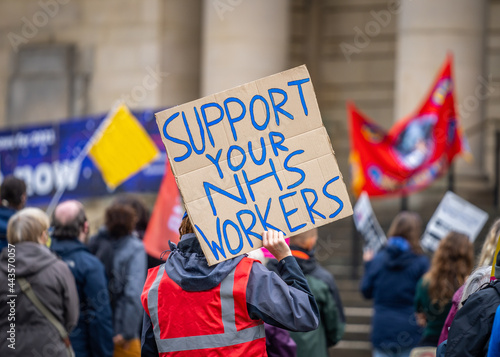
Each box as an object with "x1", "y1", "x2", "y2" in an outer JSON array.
[{"x1": 141, "y1": 234, "x2": 319, "y2": 357}]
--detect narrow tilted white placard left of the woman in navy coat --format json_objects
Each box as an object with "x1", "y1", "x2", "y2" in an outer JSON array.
[{"x1": 353, "y1": 191, "x2": 387, "y2": 253}]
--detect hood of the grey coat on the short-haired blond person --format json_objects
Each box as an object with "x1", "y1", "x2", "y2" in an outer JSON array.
[{"x1": 0, "y1": 242, "x2": 58, "y2": 277}]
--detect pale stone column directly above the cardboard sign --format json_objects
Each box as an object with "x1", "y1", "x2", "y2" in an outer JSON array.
[{"x1": 201, "y1": 0, "x2": 290, "y2": 96}]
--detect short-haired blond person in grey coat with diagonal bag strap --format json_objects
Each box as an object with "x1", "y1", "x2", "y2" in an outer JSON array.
[{"x1": 0, "y1": 208, "x2": 79, "y2": 357}]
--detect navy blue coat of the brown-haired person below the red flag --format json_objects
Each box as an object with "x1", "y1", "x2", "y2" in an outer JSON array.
[{"x1": 361, "y1": 241, "x2": 429, "y2": 352}]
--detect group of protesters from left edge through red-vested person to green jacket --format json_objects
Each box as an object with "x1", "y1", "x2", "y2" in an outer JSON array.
[{"x1": 0, "y1": 177, "x2": 345, "y2": 357}]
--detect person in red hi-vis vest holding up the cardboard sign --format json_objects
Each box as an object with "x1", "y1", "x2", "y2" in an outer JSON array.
[{"x1": 142, "y1": 215, "x2": 319, "y2": 357}]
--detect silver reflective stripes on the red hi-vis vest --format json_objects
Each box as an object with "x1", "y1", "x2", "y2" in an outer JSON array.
[{"x1": 148, "y1": 265, "x2": 266, "y2": 353}]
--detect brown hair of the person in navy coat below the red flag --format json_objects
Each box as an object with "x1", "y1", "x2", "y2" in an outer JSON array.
[{"x1": 387, "y1": 211, "x2": 423, "y2": 254}]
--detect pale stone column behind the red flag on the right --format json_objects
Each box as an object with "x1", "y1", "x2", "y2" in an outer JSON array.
[{"x1": 394, "y1": 0, "x2": 488, "y2": 172}]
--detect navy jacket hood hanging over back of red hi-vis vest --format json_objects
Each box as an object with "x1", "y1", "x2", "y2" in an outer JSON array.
[{"x1": 165, "y1": 233, "x2": 244, "y2": 291}]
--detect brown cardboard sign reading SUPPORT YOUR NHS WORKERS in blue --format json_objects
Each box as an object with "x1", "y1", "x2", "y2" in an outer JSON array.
[{"x1": 156, "y1": 66, "x2": 352, "y2": 265}]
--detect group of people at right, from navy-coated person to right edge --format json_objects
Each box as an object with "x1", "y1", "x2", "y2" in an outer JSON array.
[{"x1": 361, "y1": 212, "x2": 500, "y2": 357}]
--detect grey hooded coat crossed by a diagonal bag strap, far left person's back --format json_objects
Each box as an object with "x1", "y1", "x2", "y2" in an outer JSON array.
[{"x1": 0, "y1": 242, "x2": 79, "y2": 357}]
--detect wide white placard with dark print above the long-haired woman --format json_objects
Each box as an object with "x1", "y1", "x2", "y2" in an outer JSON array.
[{"x1": 420, "y1": 191, "x2": 488, "y2": 252}]
